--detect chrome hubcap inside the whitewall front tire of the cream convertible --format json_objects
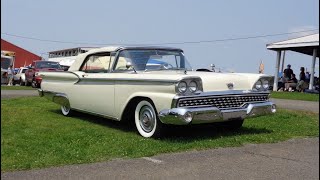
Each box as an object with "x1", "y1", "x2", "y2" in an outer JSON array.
[{"x1": 139, "y1": 106, "x2": 155, "y2": 133}]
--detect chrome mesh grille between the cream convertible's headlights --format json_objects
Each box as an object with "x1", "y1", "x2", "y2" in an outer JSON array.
[{"x1": 177, "y1": 94, "x2": 268, "y2": 109}]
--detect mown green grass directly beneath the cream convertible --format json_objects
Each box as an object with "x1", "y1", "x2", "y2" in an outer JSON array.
[{"x1": 1, "y1": 97, "x2": 319, "y2": 172}]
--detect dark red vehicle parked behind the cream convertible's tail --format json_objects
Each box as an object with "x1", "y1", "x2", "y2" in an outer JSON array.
[{"x1": 25, "y1": 61, "x2": 63, "y2": 88}]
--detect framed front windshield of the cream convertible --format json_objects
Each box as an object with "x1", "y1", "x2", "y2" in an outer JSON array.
[{"x1": 115, "y1": 50, "x2": 192, "y2": 71}]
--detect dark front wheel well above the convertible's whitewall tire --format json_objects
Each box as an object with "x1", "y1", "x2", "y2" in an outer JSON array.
[{"x1": 121, "y1": 96, "x2": 154, "y2": 122}]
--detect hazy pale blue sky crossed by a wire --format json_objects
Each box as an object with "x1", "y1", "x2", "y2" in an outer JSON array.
[{"x1": 1, "y1": 0, "x2": 319, "y2": 75}]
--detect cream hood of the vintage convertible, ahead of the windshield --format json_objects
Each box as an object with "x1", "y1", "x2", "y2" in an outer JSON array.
[{"x1": 140, "y1": 71, "x2": 270, "y2": 92}]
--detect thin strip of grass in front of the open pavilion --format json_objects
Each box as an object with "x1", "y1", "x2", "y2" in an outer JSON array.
[{"x1": 271, "y1": 91, "x2": 319, "y2": 101}]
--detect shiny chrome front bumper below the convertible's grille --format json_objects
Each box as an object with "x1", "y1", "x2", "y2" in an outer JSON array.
[{"x1": 159, "y1": 101, "x2": 276, "y2": 125}]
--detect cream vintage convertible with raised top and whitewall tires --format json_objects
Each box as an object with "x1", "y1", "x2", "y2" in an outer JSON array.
[{"x1": 38, "y1": 47, "x2": 276, "y2": 137}]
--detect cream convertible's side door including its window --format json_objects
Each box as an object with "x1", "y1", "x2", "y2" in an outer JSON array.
[{"x1": 69, "y1": 52, "x2": 115, "y2": 118}]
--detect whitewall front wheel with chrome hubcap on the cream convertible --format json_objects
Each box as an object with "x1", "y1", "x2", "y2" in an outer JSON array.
[{"x1": 135, "y1": 100, "x2": 163, "y2": 138}]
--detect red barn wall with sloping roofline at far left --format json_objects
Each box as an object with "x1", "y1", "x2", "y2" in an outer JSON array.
[{"x1": 1, "y1": 39, "x2": 41, "y2": 68}]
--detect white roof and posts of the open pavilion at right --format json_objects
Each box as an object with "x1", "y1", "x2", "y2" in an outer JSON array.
[{"x1": 267, "y1": 33, "x2": 319, "y2": 91}]
